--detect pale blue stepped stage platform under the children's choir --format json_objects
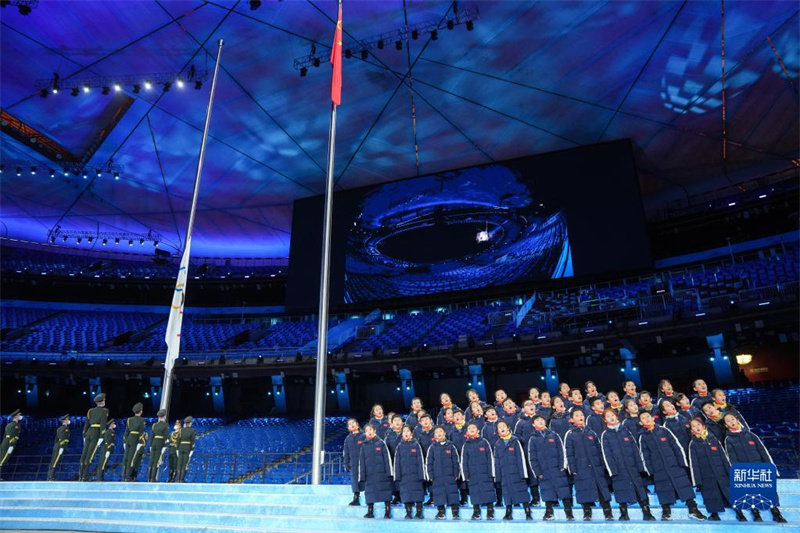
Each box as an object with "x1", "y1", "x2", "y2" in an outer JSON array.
[{"x1": 0, "y1": 479, "x2": 800, "y2": 533}]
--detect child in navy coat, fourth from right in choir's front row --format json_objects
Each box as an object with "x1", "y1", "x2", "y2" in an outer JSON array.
[{"x1": 600, "y1": 409, "x2": 655, "y2": 521}]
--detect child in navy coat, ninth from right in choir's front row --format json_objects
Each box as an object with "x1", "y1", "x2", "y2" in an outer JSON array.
[{"x1": 425, "y1": 426, "x2": 461, "y2": 520}]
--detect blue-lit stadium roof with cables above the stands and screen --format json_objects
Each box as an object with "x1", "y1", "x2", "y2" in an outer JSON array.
[{"x1": 0, "y1": 0, "x2": 800, "y2": 257}]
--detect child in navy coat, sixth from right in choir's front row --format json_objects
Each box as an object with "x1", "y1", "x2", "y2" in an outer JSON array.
[{"x1": 527, "y1": 415, "x2": 574, "y2": 520}]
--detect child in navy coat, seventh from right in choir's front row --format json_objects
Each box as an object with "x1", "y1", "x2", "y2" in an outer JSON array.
[{"x1": 494, "y1": 420, "x2": 533, "y2": 520}]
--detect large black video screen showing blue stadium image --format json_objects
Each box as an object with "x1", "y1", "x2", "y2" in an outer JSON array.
[{"x1": 287, "y1": 141, "x2": 651, "y2": 309}]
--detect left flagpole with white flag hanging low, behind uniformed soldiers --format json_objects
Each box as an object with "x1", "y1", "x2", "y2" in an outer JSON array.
[{"x1": 160, "y1": 39, "x2": 223, "y2": 410}]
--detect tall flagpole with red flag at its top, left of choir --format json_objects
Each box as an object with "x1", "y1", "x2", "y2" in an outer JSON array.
[{"x1": 311, "y1": 0, "x2": 342, "y2": 485}]
